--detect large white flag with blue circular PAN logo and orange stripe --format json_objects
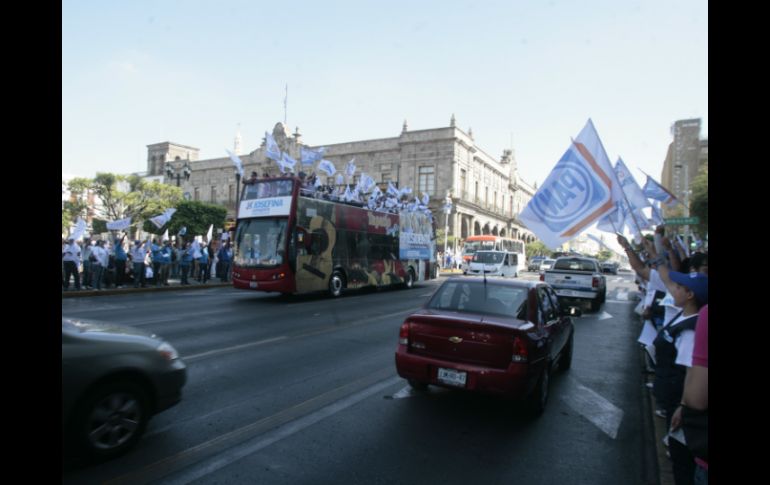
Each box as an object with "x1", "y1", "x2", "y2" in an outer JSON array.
[{"x1": 520, "y1": 119, "x2": 623, "y2": 248}]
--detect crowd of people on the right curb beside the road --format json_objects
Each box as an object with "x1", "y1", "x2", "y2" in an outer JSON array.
[{"x1": 618, "y1": 226, "x2": 708, "y2": 485}]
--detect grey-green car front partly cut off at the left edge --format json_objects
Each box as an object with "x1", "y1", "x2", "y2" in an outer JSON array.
[{"x1": 61, "y1": 318, "x2": 187, "y2": 459}]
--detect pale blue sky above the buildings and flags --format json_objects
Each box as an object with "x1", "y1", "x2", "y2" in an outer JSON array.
[{"x1": 62, "y1": 0, "x2": 708, "y2": 188}]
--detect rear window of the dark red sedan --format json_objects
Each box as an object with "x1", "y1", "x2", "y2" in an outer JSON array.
[{"x1": 428, "y1": 279, "x2": 528, "y2": 320}]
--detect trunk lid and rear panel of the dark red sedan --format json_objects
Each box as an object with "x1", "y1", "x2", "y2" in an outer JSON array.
[{"x1": 407, "y1": 312, "x2": 528, "y2": 369}]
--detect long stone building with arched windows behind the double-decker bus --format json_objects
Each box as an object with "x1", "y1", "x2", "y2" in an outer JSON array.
[{"x1": 147, "y1": 116, "x2": 536, "y2": 242}]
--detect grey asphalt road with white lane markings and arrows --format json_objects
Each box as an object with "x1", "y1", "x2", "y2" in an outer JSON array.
[{"x1": 62, "y1": 274, "x2": 657, "y2": 484}]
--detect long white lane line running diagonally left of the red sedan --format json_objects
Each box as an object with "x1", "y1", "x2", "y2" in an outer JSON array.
[{"x1": 163, "y1": 376, "x2": 401, "y2": 484}]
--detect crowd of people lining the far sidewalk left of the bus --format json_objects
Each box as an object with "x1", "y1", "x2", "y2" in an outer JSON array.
[{"x1": 62, "y1": 235, "x2": 233, "y2": 291}]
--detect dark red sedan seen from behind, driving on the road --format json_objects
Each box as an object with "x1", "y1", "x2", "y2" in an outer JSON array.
[{"x1": 396, "y1": 277, "x2": 580, "y2": 414}]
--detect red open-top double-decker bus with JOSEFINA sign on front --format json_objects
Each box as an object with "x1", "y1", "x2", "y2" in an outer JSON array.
[{"x1": 233, "y1": 177, "x2": 438, "y2": 297}]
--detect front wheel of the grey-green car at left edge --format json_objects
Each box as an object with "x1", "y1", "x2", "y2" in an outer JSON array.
[{"x1": 73, "y1": 381, "x2": 150, "y2": 459}]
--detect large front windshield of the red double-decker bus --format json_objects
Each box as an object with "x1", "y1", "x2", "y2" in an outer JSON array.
[{"x1": 233, "y1": 217, "x2": 288, "y2": 267}]
